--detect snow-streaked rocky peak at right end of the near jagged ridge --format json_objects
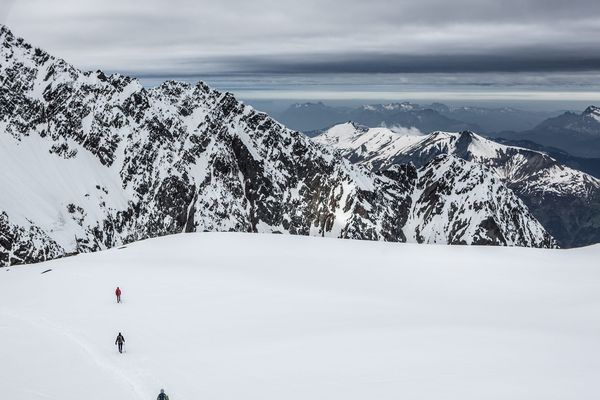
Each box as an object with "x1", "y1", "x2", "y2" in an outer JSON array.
[{"x1": 407, "y1": 156, "x2": 553, "y2": 247}]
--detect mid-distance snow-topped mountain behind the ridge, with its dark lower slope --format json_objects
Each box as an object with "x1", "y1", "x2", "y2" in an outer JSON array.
[{"x1": 322, "y1": 124, "x2": 600, "y2": 247}]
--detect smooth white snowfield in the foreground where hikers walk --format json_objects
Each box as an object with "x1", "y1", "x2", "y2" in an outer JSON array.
[{"x1": 0, "y1": 233, "x2": 600, "y2": 400}]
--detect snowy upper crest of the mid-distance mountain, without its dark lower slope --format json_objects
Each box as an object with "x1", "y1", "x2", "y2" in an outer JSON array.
[{"x1": 322, "y1": 124, "x2": 600, "y2": 194}]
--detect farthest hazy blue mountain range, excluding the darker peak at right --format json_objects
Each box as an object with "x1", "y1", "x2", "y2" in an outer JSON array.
[{"x1": 275, "y1": 102, "x2": 554, "y2": 136}]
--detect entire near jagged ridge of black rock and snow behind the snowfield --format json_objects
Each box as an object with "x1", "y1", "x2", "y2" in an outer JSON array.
[{"x1": 0, "y1": 27, "x2": 555, "y2": 265}]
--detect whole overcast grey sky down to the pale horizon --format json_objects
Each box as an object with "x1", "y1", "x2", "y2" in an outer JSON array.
[{"x1": 0, "y1": 0, "x2": 600, "y2": 107}]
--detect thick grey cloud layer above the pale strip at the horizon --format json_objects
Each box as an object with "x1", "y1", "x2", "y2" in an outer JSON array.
[{"x1": 0, "y1": 0, "x2": 600, "y2": 75}]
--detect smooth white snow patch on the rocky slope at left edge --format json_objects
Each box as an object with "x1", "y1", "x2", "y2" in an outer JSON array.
[{"x1": 0, "y1": 132, "x2": 127, "y2": 248}]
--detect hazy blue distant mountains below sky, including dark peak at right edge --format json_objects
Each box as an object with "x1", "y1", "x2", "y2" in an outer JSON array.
[{"x1": 277, "y1": 102, "x2": 600, "y2": 160}]
